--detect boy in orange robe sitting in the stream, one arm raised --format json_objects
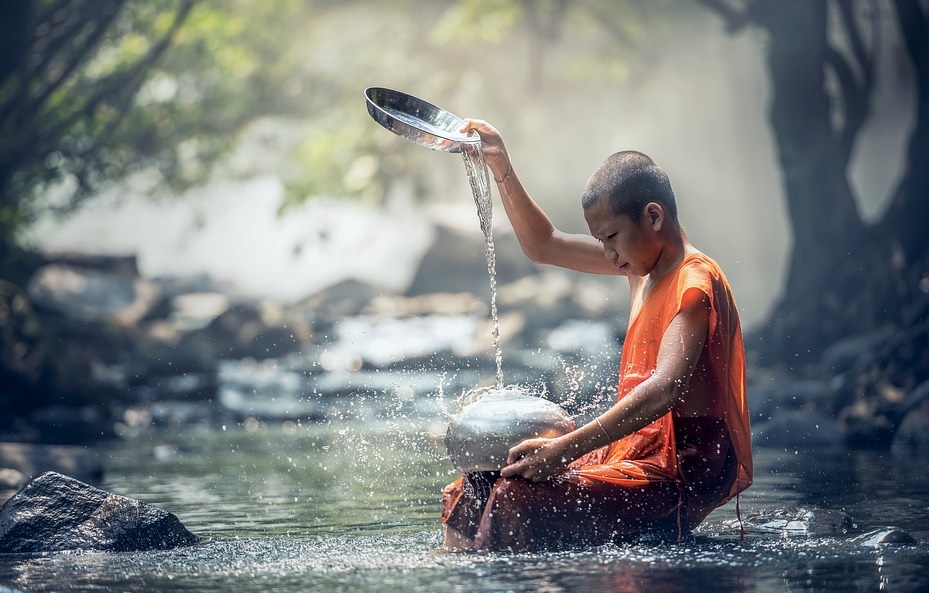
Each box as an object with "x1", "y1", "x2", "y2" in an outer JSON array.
[{"x1": 442, "y1": 119, "x2": 752, "y2": 551}]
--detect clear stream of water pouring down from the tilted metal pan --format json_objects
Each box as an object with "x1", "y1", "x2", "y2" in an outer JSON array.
[{"x1": 461, "y1": 142, "x2": 503, "y2": 389}]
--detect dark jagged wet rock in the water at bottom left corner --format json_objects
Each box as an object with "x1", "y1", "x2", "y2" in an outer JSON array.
[{"x1": 0, "y1": 472, "x2": 197, "y2": 553}]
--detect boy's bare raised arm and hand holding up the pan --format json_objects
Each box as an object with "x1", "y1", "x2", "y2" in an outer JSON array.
[{"x1": 461, "y1": 119, "x2": 618, "y2": 274}]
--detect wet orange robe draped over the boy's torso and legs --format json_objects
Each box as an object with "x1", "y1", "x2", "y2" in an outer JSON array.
[{"x1": 442, "y1": 253, "x2": 752, "y2": 551}]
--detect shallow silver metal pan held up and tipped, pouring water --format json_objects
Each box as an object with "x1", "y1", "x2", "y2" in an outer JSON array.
[{"x1": 365, "y1": 87, "x2": 481, "y2": 152}]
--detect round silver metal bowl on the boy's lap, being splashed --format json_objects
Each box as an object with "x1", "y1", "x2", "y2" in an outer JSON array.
[{"x1": 445, "y1": 387, "x2": 575, "y2": 473}]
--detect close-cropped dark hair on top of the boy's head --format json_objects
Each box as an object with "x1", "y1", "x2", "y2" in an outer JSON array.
[{"x1": 581, "y1": 150, "x2": 677, "y2": 221}]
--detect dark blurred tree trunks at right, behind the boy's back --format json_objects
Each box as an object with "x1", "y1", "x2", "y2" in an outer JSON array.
[{"x1": 701, "y1": 0, "x2": 929, "y2": 360}]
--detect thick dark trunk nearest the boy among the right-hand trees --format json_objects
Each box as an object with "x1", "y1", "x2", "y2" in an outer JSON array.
[{"x1": 752, "y1": 0, "x2": 867, "y2": 362}]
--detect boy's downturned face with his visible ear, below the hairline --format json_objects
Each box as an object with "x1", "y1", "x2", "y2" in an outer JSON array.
[{"x1": 584, "y1": 200, "x2": 664, "y2": 277}]
